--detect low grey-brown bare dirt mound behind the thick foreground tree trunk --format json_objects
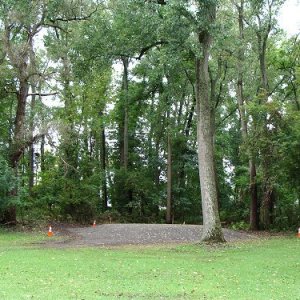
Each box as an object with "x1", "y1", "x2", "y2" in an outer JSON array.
[{"x1": 47, "y1": 224, "x2": 256, "y2": 247}]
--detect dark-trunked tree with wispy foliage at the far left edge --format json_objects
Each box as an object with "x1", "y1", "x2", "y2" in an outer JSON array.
[{"x1": 0, "y1": 1, "x2": 45, "y2": 223}]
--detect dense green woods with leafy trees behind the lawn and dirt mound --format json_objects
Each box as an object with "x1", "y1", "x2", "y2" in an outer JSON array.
[{"x1": 0, "y1": 0, "x2": 300, "y2": 230}]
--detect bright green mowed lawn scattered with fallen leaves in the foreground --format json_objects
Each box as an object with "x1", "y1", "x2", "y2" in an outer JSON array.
[{"x1": 0, "y1": 231, "x2": 300, "y2": 300}]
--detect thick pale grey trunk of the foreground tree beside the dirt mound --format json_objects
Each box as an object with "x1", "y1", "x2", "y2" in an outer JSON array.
[{"x1": 196, "y1": 22, "x2": 225, "y2": 242}]
